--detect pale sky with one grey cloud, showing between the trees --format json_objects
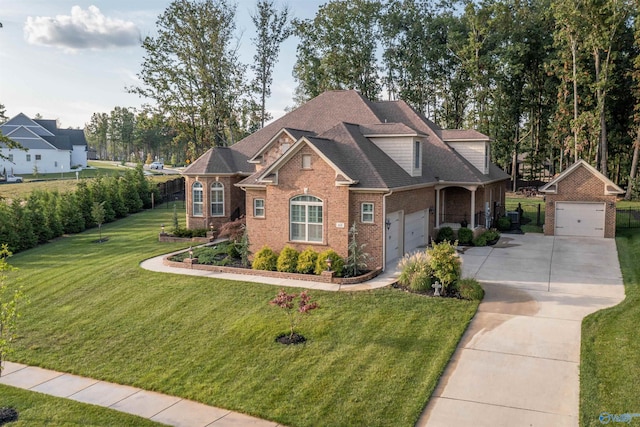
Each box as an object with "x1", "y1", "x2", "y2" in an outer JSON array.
[{"x1": 0, "y1": 0, "x2": 326, "y2": 128}]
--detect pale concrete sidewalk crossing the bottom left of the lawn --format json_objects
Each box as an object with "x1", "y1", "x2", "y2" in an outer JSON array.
[{"x1": 0, "y1": 362, "x2": 279, "y2": 427}]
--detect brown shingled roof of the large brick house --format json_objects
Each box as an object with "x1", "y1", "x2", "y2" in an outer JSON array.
[{"x1": 189, "y1": 90, "x2": 509, "y2": 189}]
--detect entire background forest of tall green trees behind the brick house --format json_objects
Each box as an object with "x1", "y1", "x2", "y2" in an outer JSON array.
[{"x1": 74, "y1": 0, "x2": 640, "y2": 197}]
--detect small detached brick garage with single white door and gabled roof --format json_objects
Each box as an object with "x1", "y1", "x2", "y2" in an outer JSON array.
[{"x1": 540, "y1": 160, "x2": 624, "y2": 238}]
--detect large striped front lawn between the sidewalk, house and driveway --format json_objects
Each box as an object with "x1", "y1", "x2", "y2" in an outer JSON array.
[{"x1": 2, "y1": 209, "x2": 478, "y2": 426}]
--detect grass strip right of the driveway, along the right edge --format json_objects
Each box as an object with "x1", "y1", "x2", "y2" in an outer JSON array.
[{"x1": 580, "y1": 229, "x2": 640, "y2": 426}]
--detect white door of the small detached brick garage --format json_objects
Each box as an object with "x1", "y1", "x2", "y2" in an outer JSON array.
[{"x1": 555, "y1": 202, "x2": 605, "y2": 237}]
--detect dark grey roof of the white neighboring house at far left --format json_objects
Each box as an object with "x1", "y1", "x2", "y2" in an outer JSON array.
[{"x1": 0, "y1": 113, "x2": 87, "y2": 151}]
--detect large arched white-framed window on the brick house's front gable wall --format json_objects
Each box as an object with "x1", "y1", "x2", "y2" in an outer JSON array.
[{"x1": 290, "y1": 196, "x2": 322, "y2": 242}]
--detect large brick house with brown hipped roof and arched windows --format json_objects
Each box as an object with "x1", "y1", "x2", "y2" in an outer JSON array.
[{"x1": 183, "y1": 90, "x2": 509, "y2": 268}]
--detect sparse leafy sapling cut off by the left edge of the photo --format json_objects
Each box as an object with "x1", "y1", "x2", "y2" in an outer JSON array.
[{"x1": 0, "y1": 244, "x2": 24, "y2": 375}]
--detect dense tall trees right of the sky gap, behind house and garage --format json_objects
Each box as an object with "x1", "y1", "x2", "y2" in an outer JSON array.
[{"x1": 294, "y1": 0, "x2": 639, "y2": 187}]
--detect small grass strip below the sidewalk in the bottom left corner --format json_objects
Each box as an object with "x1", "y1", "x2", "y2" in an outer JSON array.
[{"x1": 0, "y1": 385, "x2": 164, "y2": 427}]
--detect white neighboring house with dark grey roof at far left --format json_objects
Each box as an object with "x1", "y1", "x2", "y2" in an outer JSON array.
[{"x1": 0, "y1": 113, "x2": 87, "y2": 175}]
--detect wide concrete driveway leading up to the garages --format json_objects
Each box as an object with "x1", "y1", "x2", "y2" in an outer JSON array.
[{"x1": 417, "y1": 234, "x2": 624, "y2": 427}]
